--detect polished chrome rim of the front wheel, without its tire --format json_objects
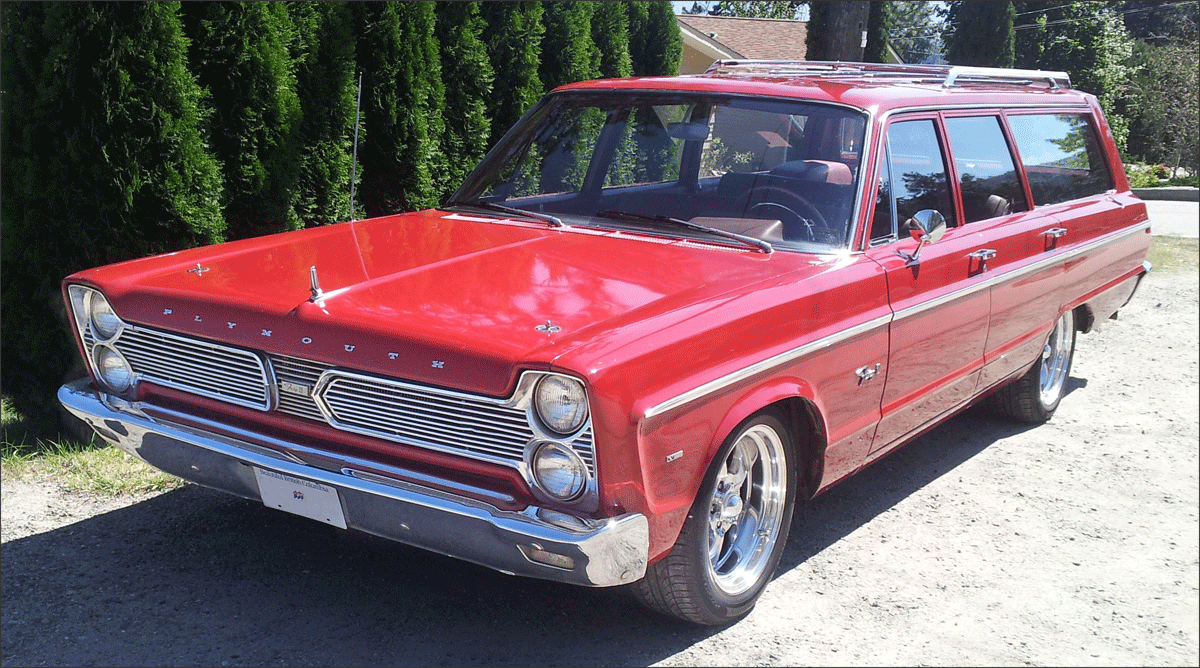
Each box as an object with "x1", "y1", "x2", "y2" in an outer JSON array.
[{"x1": 708, "y1": 423, "x2": 787, "y2": 596}]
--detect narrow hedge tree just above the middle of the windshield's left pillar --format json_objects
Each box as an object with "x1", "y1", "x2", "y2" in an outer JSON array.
[{"x1": 481, "y1": 2, "x2": 545, "y2": 143}]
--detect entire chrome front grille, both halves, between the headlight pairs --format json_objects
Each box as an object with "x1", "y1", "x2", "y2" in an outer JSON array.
[{"x1": 100, "y1": 325, "x2": 595, "y2": 476}]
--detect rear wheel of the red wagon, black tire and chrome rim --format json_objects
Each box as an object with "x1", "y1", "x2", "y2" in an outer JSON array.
[{"x1": 988, "y1": 311, "x2": 1075, "y2": 425}]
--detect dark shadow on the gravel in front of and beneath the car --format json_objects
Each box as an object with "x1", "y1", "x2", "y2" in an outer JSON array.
[{"x1": 0, "y1": 400, "x2": 1051, "y2": 666}]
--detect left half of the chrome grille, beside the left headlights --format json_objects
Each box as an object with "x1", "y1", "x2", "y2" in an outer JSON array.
[{"x1": 108, "y1": 326, "x2": 271, "y2": 410}]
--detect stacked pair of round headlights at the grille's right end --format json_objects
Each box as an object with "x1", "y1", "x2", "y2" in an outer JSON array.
[{"x1": 529, "y1": 375, "x2": 588, "y2": 501}]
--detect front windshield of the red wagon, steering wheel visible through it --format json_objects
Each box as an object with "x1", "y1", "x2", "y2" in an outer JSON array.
[{"x1": 448, "y1": 91, "x2": 865, "y2": 252}]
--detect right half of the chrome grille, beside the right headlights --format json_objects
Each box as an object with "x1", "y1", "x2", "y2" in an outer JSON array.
[{"x1": 317, "y1": 372, "x2": 594, "y2": 470}]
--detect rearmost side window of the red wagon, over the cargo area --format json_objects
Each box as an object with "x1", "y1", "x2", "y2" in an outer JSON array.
[{"x1": 1008, "y1": 114, "x2": 1112, "y2": 206}]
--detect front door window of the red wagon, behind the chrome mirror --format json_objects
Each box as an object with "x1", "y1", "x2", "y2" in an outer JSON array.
[{"x1": 888, "y1": 119, "x2": 958, "y2": 227}]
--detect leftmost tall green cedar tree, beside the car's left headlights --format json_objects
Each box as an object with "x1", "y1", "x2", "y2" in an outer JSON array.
[{"x1": 0, "y1": 2, "x2": 223, "y2": 421}]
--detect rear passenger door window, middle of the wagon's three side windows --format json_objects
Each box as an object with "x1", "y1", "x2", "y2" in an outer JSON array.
[{"x1": 946, "y1": 116, "x2": 1028, "y2": 223}]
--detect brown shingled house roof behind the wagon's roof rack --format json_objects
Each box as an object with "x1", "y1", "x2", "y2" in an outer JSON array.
[{"x1": 676, "y1": 14, "x2": 808, "y2": 60}]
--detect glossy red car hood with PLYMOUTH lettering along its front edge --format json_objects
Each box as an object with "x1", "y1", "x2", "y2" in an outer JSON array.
[{"x1": 75, "y1": 211, "x2": 799, "y2": 396}]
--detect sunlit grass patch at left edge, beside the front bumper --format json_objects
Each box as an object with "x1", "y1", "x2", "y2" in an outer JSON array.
[{"x1": 0, "y1": 398, "x2": 184, "y2": 495}]
